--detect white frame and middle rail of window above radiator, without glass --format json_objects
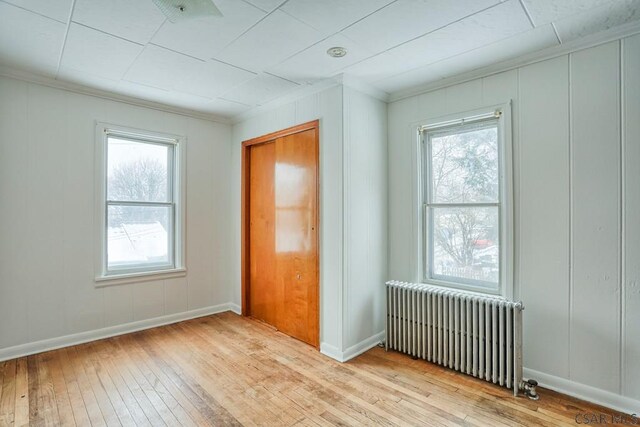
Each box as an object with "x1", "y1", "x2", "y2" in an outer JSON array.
[{"x1": 417, "y1": 102, "x2": 514, "y2": 298}]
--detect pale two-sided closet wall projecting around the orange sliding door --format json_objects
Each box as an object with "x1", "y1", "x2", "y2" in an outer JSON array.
[{"x1": 232, "y1": 85, "x2": 387, "y2": 360}]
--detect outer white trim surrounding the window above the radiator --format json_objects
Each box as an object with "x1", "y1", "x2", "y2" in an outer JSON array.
[{"x1": 414, "y1": 102, "x2": 515, "y2": 298}]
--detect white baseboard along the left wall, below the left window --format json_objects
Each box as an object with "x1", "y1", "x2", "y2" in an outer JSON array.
[{"x1": 0, "y1": 303, "x2": 240, "y2": 362}]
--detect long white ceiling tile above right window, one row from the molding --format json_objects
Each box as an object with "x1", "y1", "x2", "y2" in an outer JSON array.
[{"x1": 391, "y1": 0, "x2": 532, "y2": 68}]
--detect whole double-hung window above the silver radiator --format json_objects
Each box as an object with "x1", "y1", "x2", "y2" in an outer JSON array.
[{"x1": 420, "y1": 110, "x2": 511, "y2": 294}]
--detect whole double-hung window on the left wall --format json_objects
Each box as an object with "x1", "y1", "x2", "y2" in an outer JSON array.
[{"x1": 97, "y1": 125, "x2": 184, "y2": 280}]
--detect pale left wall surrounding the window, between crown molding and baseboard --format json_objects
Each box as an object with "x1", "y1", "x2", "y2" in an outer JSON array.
[{"x1": 0, "y1": 77, "x2": 232, "y2": 356}]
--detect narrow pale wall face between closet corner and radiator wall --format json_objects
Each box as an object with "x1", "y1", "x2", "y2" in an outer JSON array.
[{"x1": 343, "y1": 86, "x2": 388, "y2": 356}]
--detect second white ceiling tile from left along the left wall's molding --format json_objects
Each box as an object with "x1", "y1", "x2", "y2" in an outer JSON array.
[{"x1": 62, "y1": 23, "x2": 142, "y2": 80}]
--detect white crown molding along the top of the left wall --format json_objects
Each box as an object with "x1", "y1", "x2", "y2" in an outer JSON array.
[{"x1": 0, "y1": 65, "x2": 231, "y2": 125}]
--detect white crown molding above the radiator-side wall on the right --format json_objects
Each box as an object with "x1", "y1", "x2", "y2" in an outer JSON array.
[{"x1": 389, "y1": 21, "x2": 640, "y2": 102}]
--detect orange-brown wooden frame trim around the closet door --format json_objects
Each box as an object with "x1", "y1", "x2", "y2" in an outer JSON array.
[{"x1": 240, "y1": 120, "x2": 320, "y2": 341}]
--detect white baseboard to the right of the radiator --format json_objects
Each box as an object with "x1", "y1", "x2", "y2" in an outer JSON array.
[{"x1": 524, "y1": 368, "x2": 640, "y2": 414}]
